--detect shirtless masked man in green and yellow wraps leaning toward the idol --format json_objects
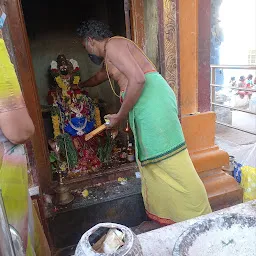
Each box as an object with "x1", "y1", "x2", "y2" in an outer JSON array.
[{"x1": 78, "y1": 21, "x2": 211, "y2": 225}]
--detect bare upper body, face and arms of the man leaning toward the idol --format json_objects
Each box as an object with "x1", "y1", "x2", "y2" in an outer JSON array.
[{"x1": 79, "y1": 37, "x2": 156, "y2": 127}]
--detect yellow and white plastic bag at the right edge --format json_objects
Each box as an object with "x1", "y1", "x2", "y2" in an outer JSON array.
[{"x1": 241, "y1": 143, "x2": 256, "y2": 202}]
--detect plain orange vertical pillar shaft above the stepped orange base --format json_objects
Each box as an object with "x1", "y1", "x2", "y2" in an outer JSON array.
[{"x1": 179, "y1": 0, "x2": 198, "y2": 116}]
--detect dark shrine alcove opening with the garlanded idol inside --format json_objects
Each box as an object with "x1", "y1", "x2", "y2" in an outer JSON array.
[{"x1": 21, "y1": 0, "x2": 138, "y2": 184}]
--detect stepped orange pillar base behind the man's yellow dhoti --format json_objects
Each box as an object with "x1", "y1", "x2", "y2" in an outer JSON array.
[{"x1": 181, "y1": 112, "x2": 243, "y2": 210}]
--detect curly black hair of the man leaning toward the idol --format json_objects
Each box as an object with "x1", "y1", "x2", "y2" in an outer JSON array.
[{"x1": 77, "y1": 20, "x2": 113, "y2": 41}]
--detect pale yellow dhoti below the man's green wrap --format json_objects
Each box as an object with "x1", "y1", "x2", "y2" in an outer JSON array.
[{"x1": 140, "y1": 150, "x2": 212, "y2": 225}]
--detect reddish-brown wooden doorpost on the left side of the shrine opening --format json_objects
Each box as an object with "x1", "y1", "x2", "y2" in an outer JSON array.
[{"x1": 7, "y1": 0, "x2": 51, "y2": 189}]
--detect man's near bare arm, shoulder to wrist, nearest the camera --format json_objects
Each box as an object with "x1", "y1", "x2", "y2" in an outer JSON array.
[{"x1": 107, "y1": 39, "x2": 145, "y2": 122}]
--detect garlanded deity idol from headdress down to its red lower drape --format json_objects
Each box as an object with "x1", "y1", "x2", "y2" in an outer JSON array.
[{"x1": 49, "y1": 55, "x2": 101, "y2": 178}]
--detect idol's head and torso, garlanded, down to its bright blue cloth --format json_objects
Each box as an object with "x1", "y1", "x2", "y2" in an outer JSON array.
[{"x1": 51, "y1": 55, "x2": 95, "y2": 136}]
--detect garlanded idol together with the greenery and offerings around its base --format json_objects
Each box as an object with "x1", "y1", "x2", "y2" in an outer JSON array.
[{"x1": 48, "y1": 54, "x2": 134, "y2": 184}]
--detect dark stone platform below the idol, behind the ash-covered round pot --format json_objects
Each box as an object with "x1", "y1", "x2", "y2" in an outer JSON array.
[{"x1": 46, "y1": 178, "x2": 146, "y2": 249}]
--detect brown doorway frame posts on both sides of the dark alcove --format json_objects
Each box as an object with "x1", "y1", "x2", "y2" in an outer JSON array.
[{"x1": 5, "y1": 0, "x2": 145, "y2": 190}]
